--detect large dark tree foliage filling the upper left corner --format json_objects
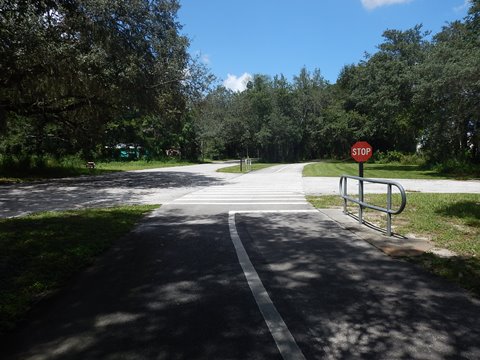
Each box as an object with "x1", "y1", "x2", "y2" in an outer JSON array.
[{"x1": 0, "y1": 0, "x2": 209, "y2": 158}]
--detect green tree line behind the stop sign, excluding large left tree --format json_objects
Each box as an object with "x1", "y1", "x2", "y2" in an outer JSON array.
[{"x1": 195, "y1": 0, "x2": 480, "y2": 166}]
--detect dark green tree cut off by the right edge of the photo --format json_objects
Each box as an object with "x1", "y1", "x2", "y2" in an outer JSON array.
[{"x1": 415, "y1": 1, "x2": 480, "y2": 162}]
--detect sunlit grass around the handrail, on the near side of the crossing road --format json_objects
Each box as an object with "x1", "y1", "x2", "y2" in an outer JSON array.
[{"x1": 308, "y1": 193, "x2": 480, "y2": 297}]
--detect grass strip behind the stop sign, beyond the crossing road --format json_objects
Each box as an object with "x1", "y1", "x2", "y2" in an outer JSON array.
[{"x1": 303, "y1": 161, "x2": 474, "y2": 179}]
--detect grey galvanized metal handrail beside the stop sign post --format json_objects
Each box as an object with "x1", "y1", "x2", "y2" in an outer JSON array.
[{"x1": 339, "y1": 175, "x2": 407, "y2": 236}]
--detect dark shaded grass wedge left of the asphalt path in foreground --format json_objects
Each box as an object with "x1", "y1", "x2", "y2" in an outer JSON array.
[{"x1": 0, "y1": 205, "x2": 158, "y2": 334}]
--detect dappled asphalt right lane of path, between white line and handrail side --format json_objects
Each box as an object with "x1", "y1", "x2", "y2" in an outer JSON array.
[{"x1": 237, "y1": 214, "x2": 480, "y2": 359}]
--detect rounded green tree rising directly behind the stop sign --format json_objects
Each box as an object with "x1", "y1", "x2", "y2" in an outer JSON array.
[{"x1": 338, "y1": 25, "x2": 428, "y2": 152}]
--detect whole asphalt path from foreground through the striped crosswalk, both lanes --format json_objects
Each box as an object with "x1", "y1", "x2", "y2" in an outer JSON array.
[{"x1": 3, "y1": 164, "x2": 480, "y2": 360}]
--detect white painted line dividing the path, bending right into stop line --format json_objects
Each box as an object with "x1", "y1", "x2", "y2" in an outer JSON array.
[{"x1": 228, "y1": 210, "x2": 317, "y2": 360}]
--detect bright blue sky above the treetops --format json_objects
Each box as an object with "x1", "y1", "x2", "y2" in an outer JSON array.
[{"x1": 178, "y1": 0, "x2": 468, "y2": 90}]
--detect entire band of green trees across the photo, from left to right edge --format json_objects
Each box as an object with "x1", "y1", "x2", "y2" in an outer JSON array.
[{"x1": 0, "y1": 0, "x2": 480, "y2": 168}]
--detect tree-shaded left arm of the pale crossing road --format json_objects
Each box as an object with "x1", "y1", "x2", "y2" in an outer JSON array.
[{"x1": 0, "y1": 171, "x2": 227, "y2": 217}]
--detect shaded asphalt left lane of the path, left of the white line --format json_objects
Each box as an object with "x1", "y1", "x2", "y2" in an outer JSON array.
[{"x1": 2, "y1": 214, "x2": 280, "y2": 360}]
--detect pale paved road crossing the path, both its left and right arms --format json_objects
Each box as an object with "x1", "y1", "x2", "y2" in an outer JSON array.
[{"x1": 0, "y1": 163, "x2": 480, "y2": 217}]
